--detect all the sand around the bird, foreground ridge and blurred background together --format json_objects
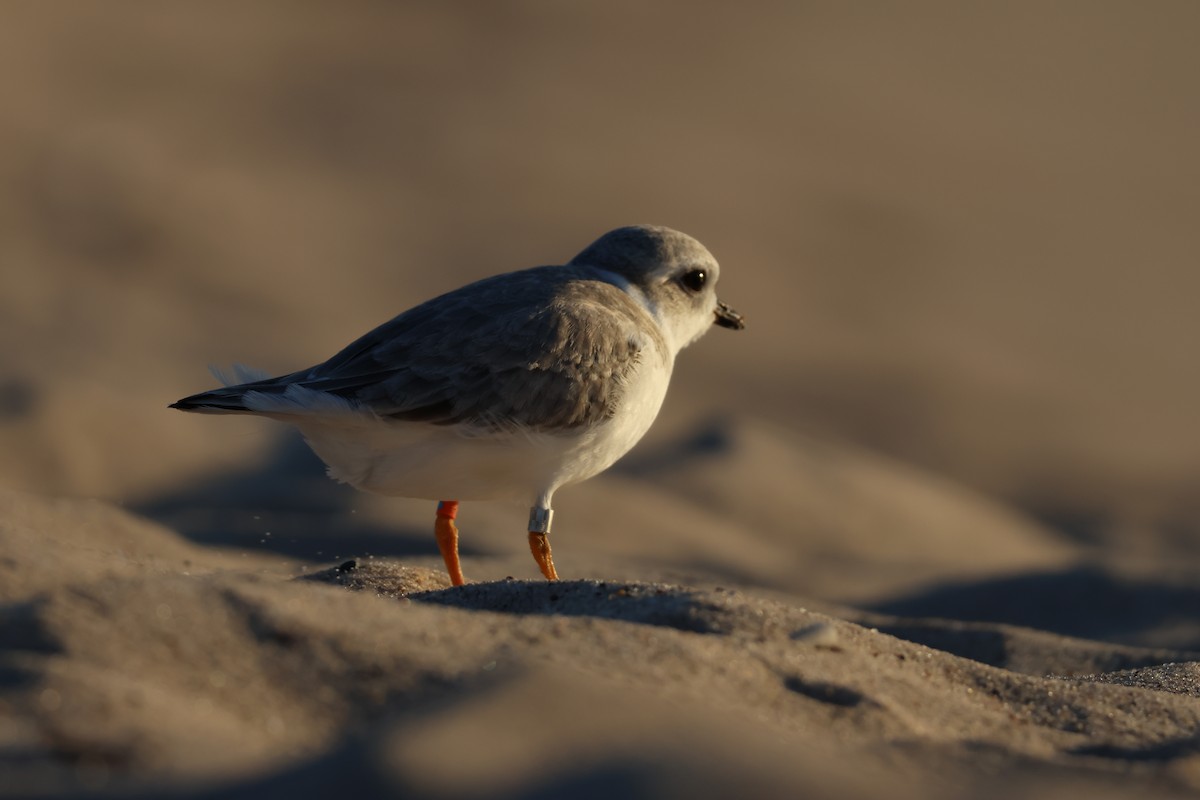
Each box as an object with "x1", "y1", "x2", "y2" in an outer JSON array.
[{"x1": 0, "y1": 1, "x2": 1200, "y2": 800}]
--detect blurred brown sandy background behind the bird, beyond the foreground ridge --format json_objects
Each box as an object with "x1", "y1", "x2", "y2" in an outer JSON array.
[{"x1": 0, "y1": 0, "x2": 1200, "y2": 796}]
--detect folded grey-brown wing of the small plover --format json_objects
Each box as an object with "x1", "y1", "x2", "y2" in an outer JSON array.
[{"x1": 234, "y1": 267, "x2": 666, "y2": 431}]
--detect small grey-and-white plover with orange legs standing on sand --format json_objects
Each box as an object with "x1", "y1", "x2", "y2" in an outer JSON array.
[{"x1": 172, "y1": 225, "x2": 744, "y2": 585}]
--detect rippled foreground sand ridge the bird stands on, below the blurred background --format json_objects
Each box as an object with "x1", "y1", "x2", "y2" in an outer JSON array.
[{"x1": 7, "y1": 493, "x2": 1200, "y2": 798}]
